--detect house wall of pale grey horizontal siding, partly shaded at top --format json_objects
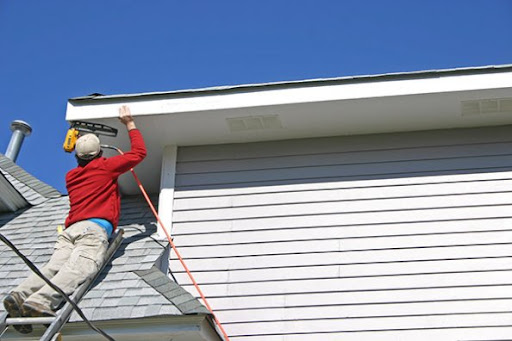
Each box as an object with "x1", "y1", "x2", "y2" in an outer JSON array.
[{"x1": 171, "y1": 126, "x2": 512, "y2": 340}]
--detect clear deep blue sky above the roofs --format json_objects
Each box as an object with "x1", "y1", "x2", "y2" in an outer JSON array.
[{"x1": 0, "y1": 0, "x2": 512, "y2": 192}]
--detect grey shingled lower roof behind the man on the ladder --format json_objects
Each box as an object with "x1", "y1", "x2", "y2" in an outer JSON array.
[{"x1": 0, "y1": 196, "x2": 208, "y2": 322}]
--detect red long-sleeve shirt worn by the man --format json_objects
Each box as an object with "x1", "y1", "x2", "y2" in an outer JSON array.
[{"x1": 65, "y1": 129, "x2": 146, "y2": 230}]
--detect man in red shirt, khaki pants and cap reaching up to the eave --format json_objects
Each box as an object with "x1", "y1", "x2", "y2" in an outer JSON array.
[{"x1": 4, "y1": 106, "x2": 146, "y2": 334}]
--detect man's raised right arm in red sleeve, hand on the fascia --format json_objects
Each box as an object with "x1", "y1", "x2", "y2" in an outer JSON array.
[{"x1": 105, "y1": 105, "x2": 146, "y2": 176}]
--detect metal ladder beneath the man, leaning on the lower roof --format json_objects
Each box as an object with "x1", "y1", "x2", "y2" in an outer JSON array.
[{"x1": 0, "y1": 229, "x2": 124, "y2": 341}]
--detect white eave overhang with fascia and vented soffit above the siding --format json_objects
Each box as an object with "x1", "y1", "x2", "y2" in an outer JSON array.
[{"x1": 66, "y1": 65, "x2": 512, "y2": 192}]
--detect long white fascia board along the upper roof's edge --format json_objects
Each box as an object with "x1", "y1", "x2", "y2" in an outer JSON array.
[{"x1": 66, "y1": 72, "x2": 512, "y2": 121}]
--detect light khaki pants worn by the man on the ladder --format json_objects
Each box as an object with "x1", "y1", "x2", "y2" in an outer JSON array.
[{"x1": 13, "y1": 220, "x2": 108, "y2": 310}]
